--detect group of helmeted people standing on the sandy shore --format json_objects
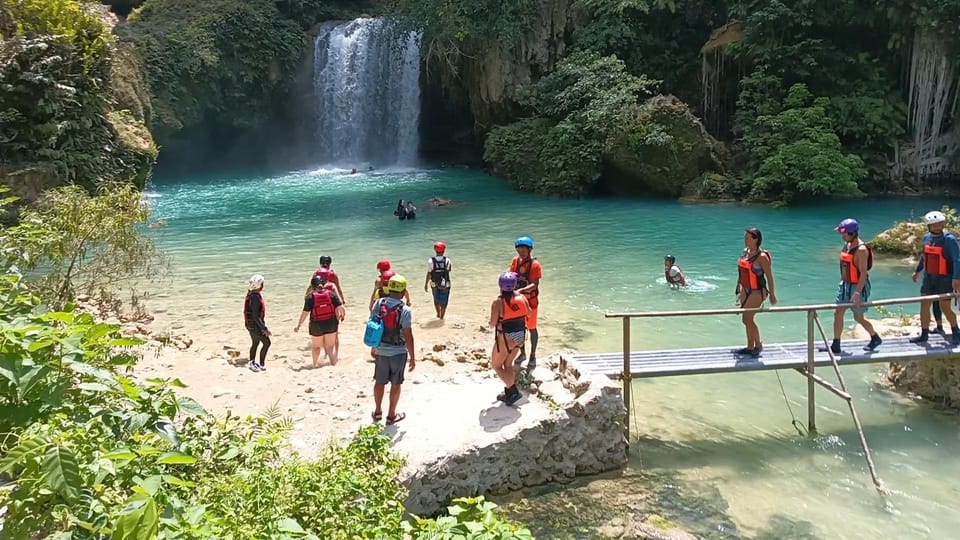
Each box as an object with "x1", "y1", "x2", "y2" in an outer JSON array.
[{"x1": 243, "y1": 236, "x2": 543, "y2": 424}]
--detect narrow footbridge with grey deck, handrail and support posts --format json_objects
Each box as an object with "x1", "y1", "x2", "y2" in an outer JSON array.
[{"x1": 567, "y1": 294, "x2": 960, "y2": 494}]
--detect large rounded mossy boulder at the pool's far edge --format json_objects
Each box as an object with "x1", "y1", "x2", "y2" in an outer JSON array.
[{"x1": 601, "y1": 96, "x2": 722, "y2": 197}]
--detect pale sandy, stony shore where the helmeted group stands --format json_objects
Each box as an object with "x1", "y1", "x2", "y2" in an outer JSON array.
[{"x1": 127, "y1": 297, "x2": 550, "y2": 461}]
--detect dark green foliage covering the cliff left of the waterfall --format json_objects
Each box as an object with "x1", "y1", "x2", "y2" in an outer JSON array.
[{"x1": 121, "y1": 0, "x2": 307, "y2": 139}]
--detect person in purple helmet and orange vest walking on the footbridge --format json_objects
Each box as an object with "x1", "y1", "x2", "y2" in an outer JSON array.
[{"x1": 830, "y1": 218, "x2": 883, "y2": 354}]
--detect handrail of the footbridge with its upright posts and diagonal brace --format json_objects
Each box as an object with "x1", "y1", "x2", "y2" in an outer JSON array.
[{"x1": 604, "y1": 292, "x2": 960, "y2": 494}]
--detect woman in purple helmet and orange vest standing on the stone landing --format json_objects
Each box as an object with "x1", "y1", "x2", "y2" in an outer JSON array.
[{"x1": 490, "y1": 272, "x2": 533, "y2": 405}]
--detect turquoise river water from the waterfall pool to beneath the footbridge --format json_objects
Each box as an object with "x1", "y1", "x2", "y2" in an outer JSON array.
[{"x1": 148, "y1": 169, "x2": 960, "y2": 539}]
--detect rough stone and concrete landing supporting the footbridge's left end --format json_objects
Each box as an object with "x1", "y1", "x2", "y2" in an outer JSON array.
[{"x1": 404, "y1": 356, "x2": 627, "y2": 515}]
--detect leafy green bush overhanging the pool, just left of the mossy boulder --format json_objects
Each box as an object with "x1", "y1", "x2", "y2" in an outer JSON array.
[{"x1": 484, "y1": 53, "x2": 657, "y2": 197}]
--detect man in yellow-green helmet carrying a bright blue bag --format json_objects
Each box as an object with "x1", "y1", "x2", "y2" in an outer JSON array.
[{"x1": 371, "y1": 274, "x2": 417, "y2": 425}]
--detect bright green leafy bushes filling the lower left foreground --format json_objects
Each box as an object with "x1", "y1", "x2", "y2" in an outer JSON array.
[{"x1": 0, "y1": 274, "x2": 530, "y2": 540}]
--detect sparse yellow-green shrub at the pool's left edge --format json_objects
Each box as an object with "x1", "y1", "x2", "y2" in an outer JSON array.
[{"x1": 0, "y1": 184, "x2": 165, "y2": 306}]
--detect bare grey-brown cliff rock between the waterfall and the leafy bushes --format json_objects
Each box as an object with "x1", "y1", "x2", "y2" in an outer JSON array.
[{"x1": 460, "y1": 0, "x2": 585, "y2": 132}]
